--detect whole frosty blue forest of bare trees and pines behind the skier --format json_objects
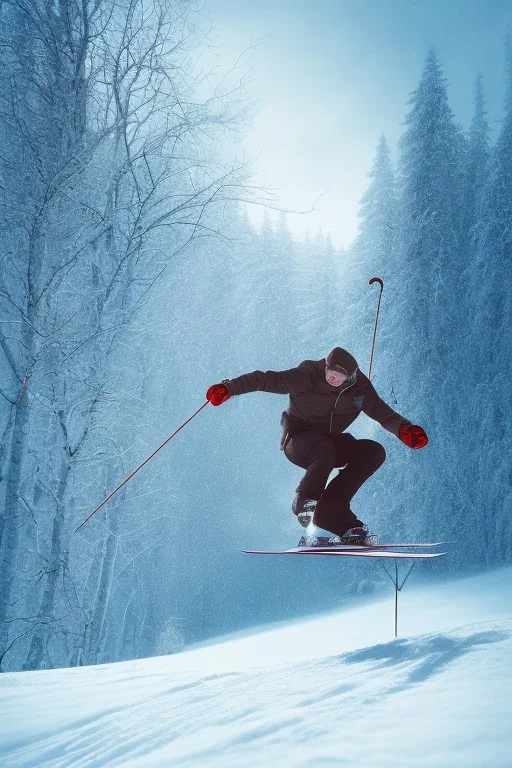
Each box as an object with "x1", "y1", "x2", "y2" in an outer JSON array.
[{"x1": 0, "y1": 0, "x2": 512, "y2": 671}]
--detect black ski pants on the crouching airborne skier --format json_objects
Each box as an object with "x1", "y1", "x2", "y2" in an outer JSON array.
[{"x1": 284, "y1": 430, "x2": 386, "y2": 536}]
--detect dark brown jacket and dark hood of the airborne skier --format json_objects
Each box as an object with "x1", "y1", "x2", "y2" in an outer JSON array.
[{"x1": 223, "y1": 347, "x2": 412, "y2": 447}]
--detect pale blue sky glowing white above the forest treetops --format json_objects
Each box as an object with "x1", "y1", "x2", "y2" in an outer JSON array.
[{"x1": 207, "y1": 0, "x2": 512, "y2": 246}]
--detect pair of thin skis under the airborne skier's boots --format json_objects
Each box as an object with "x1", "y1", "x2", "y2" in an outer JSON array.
[{"x1": 240, "y1": 541, "x2": 446, "y2": 560}]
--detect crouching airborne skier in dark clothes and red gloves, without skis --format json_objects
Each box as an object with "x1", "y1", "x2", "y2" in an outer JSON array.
[{"x1": 206, "y1": 347, "x2": 428, "y2": 545}]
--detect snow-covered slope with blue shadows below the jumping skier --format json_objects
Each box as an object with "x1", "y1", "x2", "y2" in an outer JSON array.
[{"x1": 0, "y1": 568, "x2": 512, "y2": 768}]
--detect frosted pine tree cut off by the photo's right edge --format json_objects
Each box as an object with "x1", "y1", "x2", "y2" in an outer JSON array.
[{"x1": 469, "y1": 30, "x2": 512, "y2": 562}]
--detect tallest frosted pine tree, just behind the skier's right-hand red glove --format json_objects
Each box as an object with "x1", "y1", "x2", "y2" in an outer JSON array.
[{"x1": 393, "y1": 48, "x2": 466, "y2": 548}]
